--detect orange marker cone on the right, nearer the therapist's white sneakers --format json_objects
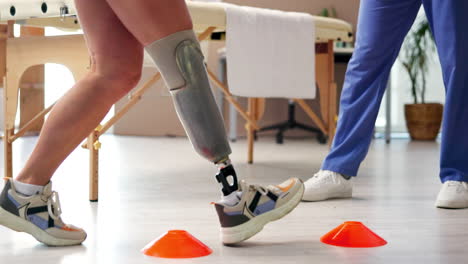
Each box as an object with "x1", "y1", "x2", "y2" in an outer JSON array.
[{"x1": 320, "y1": 221, "x2": 387, "y2": 247}]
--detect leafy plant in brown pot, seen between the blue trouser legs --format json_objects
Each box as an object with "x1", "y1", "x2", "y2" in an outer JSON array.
[{"x1": 400, "y1": 14, "x2": 443, "y2": 140}]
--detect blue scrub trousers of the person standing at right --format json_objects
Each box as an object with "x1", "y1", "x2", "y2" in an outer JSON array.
[{"x1": 322, "y1": 0, "x2": 468, "y2": 182}]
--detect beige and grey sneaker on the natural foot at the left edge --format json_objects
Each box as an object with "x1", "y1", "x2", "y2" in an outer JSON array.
[{"x1": 0, "y1": 180, "x2": 86, "y2": 246}]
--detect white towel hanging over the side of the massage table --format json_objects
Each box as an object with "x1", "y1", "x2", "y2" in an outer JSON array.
[{"x1": 226, "y1": 5, "x2": 316, "y2": 98}]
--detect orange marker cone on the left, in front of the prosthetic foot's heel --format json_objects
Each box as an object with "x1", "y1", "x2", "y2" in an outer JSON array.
[{"x1": 142, "y1": 230, "x2": 213, "y2": 258}]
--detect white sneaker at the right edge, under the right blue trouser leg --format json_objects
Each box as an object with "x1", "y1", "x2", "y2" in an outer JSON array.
[{"x1": 435, "y1": 181, "x2": 468, "y2": 209}]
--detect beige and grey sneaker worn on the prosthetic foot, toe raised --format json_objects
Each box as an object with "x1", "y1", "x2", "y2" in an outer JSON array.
[{"x1": 215, "y1": 178, "x2": 304, "y2": 245}]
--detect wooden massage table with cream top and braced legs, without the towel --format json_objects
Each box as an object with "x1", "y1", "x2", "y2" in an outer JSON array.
[{"x1": 0, "y1": 0, "x2": 353, "y2": 201}]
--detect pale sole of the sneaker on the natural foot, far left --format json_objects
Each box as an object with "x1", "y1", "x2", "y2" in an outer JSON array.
[{"x1": 0, "y1": 207, "x2": 84, "y2": 247}]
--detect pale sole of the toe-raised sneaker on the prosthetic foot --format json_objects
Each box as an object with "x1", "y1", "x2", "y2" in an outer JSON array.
[{"x1": 221, "y1": 184, "x2": 305, "y2": 245}]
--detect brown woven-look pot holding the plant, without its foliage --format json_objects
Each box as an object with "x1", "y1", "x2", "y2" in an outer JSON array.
[{"x1": 405, "y1": 103, "x2": 444, "y2": 140}]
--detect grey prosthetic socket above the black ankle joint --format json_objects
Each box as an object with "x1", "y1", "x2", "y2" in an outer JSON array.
[{"x1": 145, "y1": 30, "x2": 231, "y2": 163}]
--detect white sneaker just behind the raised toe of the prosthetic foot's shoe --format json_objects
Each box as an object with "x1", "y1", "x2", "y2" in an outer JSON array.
[{"x1": 302, "y1": 170, "x2": 354, "y2": 202}]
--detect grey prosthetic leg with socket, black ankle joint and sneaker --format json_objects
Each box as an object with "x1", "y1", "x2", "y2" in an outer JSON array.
[{"x1": 146, "y1": 30, "x2": 304, "y2": 244}]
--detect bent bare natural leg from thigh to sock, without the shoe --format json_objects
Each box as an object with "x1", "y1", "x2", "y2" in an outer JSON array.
[{"x1": 17, "y1": 0, "x2": 144, "y2": 185}]
